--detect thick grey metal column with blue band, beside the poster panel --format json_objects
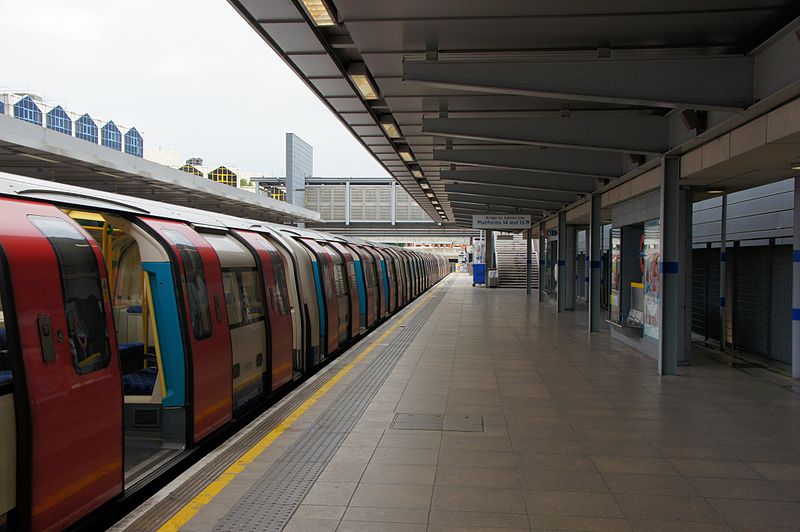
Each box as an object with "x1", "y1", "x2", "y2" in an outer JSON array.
[{"x1": 658, "y1": 157, "x2": 687, "y2": 375}]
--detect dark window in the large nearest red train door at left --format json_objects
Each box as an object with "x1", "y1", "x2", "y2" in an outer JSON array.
[{"x1": 29, "y1": 216, "x2": 111, "y2": 374}]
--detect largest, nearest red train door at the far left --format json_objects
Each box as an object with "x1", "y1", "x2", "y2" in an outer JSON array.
[{"x1": 0, "y1": 200, "x2": 123, "y2": 529}]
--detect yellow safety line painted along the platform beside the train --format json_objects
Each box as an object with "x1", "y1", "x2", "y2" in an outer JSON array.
[{"x1": 159, "y1": 279, "x2": 444, "y2": 531}]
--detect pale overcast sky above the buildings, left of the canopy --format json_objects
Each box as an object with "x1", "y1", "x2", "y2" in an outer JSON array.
[{"x1": 0, "y1": 0, "x2": 386, "y2": 176}]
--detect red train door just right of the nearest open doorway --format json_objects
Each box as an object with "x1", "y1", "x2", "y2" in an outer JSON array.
[{"x1": 140, "y1": 217, "x2": 233, "y2": 442}]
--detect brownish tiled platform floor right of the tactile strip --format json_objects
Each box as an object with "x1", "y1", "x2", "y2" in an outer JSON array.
[{"x1": 187, "y1": 275, "x2": 800, "y2": 531}]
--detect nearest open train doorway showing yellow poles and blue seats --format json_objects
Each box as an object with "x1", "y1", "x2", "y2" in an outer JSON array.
[{"x1": 65, "y1": 210, "x2": 186, "y2": 487}]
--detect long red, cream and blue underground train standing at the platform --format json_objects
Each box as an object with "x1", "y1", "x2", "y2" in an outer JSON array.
[{"x1": 0, "y1": 173, "x2": 449, "y2": 530}]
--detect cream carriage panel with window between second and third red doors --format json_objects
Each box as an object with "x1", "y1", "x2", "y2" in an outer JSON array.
[{"x1": 202, "y1": 231, "x2": 271, "y2": 416}]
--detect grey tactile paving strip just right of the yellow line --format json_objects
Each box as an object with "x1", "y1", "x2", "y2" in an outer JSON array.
[{"x1": 215, "y1": 280, "x2": 445, "y2": 531}]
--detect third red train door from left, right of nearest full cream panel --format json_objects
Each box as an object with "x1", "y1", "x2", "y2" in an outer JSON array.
[{"x1": 236, "y1": 231, "x2": 296, "y2": 391}]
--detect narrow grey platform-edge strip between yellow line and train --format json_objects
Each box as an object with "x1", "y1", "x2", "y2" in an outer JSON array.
[{"x1": 126, "y1": 281, "x2": 450, "y2": 530}]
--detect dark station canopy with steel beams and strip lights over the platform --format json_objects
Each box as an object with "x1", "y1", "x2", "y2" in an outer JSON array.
[{"x1": 230, "y1": 0, "x2": 800, "y2": 225}]
